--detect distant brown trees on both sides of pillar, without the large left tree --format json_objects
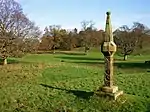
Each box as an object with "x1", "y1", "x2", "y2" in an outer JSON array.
[{"x1": 39, "y1": 21, "x2": 150, "y2": 60}]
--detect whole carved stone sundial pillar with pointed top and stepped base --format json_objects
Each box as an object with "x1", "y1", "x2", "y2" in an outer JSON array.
[{"x1": 100, "y1": 12, "x2": 123, "y2": 100}]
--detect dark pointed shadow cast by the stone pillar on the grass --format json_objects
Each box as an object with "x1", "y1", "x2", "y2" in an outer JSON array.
[{"x1": 40, "y1": 84, "x2": 94, "y2": 100}]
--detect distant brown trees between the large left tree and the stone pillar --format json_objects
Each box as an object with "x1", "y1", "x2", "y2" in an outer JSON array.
[{"x1": 39, "y1": 21, "x2": 104, "y2": 53}]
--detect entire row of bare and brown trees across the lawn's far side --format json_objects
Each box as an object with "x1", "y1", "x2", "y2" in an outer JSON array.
[{"x1": 0, "y1": 0, "x2": 150, "y2": 64}]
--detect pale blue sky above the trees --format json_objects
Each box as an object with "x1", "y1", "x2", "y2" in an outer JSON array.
[{"x1": 16, "y1": 0, "x2": 150, "y2": 30}]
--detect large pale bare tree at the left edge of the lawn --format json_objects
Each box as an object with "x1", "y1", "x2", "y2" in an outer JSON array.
[{"x1": 0, "y1": 0, "x2": 41, "y2": 64}]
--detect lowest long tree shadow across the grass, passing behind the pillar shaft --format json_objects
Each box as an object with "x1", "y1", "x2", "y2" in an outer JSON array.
[{"x1": 70, "y1": 61, "x2": 150, "y2": 69}]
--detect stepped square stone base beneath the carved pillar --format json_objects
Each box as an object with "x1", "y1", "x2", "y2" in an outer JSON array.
[{"x1": 96, "y1": 86, "x2": 123, "y2": 100}]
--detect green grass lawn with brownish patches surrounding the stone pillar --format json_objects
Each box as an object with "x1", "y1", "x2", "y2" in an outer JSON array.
[{"x1": 0, "y1": 52, "x2": 150, "y2": 112}]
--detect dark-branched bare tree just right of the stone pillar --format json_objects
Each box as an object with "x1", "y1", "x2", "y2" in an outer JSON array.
[{"x1": 114, "y1": 22, "x2": 149, "y2": 60}]
